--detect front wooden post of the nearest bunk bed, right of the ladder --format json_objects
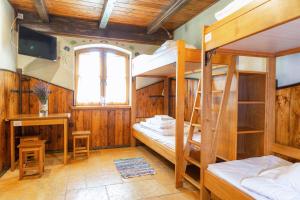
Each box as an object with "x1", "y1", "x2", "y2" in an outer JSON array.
[{"x1": 200, "y1": 27, "x2": 213, "y2": 200}]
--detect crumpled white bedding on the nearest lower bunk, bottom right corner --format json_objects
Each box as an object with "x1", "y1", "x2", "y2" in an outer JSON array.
[{"x1": 241, "y1": 163, "x2": 300, "y2": 200}]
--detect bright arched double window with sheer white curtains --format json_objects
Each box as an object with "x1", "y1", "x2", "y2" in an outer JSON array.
[{"x1": 75, "y1": 48, "x2": 129, "y2": 105}]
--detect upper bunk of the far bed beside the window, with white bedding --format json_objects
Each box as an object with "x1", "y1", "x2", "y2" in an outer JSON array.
[{"x1": 132, "y1": 40, "x2": 230, "y2": 77}]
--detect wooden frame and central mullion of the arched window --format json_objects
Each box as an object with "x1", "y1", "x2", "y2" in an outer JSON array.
[{"x1": 74, "y1": 47, "x2": 130, "y2": 106}]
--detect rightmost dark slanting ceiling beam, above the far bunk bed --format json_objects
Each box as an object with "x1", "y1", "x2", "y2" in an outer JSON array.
[{"x1": 147, "y1": 0, "x2": 190, "y2": 34}]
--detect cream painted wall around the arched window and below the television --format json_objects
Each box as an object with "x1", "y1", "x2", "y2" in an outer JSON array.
[{"x1": 18, "y1": 36, "x2": 158, "y2": 90}]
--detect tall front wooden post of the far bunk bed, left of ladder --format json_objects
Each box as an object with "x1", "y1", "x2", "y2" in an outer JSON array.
[{"x1": 175, "y1": 40, "x2": 185, "y2": 188}]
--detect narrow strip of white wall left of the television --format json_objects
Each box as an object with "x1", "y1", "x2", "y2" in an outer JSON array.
[{"x1": 0, "y1": 0, "x2": 17, "y2": 71}]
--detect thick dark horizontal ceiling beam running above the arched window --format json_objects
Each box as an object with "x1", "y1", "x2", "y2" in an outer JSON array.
[{"x1": 18, "y1": 11, "x2": 168, "y2": 44}]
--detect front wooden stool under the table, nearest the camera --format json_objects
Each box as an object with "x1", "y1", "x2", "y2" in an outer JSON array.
[{"x1": 18, "y1": 140, "x2": 45, "y2": 179}]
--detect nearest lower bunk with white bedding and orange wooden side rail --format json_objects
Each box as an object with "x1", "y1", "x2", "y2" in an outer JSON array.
[{"x1": 204, "y1": 155, "x2": 300, "y2": 200}]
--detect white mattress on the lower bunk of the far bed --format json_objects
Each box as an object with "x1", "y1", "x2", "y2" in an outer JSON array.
[{"x1": 133, "y1": 123, "x2": 201, "y2": 152}]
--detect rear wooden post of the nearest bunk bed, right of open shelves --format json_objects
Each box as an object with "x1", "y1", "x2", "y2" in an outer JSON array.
[{"x1": 264, "y1": 57, "x2": 276, "y2": 155}]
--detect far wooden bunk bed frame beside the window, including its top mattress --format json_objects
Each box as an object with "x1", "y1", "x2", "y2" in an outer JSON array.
[{"x1": 131, "y1": 40, "x2": 231, "y2": 187}]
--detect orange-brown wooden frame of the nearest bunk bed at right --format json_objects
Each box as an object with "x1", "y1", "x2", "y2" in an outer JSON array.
[{"x1": 200, "y1": 0, "x2": 300, "y2": 200}]
